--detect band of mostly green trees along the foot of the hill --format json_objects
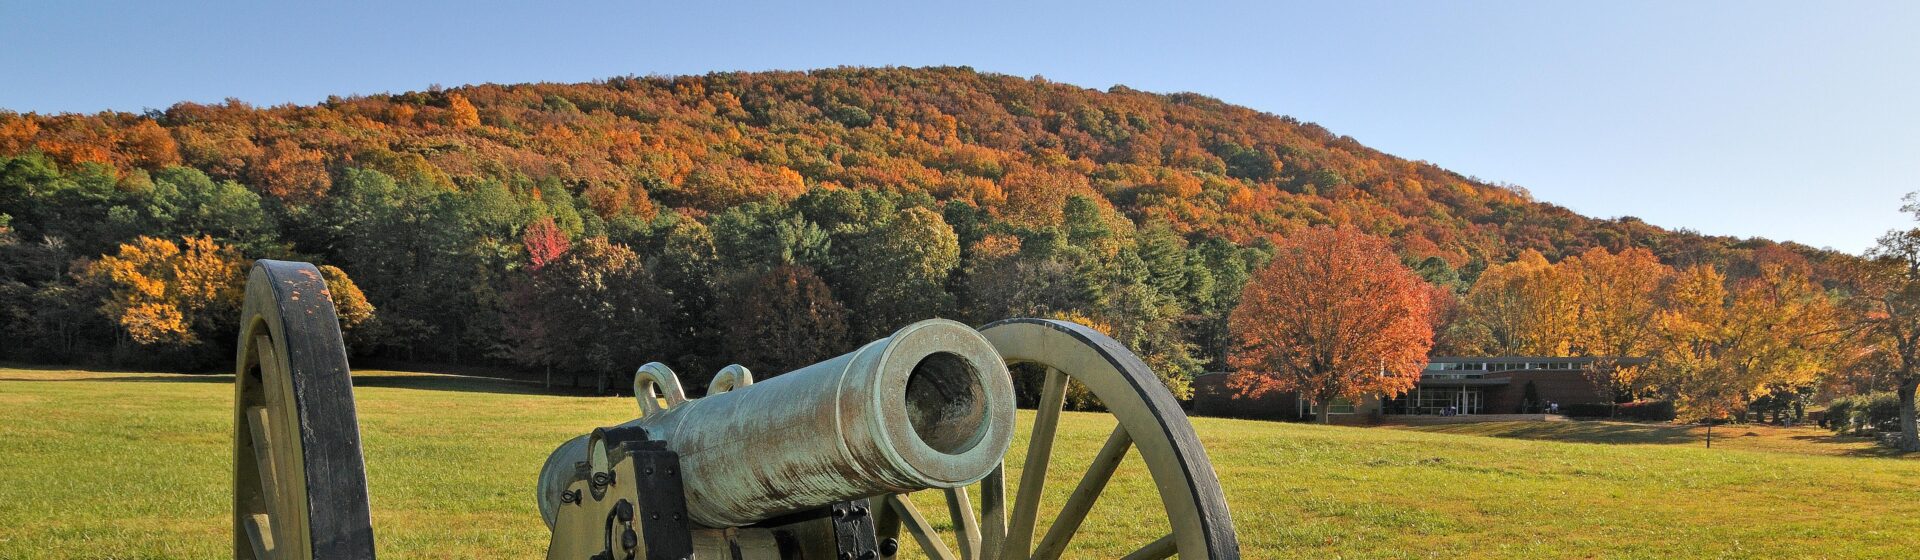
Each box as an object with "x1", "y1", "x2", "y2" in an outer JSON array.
[{"x1": 0, "y1": 155, "x2": 1265, "y2": 393}]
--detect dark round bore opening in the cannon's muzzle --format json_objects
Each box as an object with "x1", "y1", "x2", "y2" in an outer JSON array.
[{"x1": 906, "y1": 353, "x2": 987, "y2": 455}]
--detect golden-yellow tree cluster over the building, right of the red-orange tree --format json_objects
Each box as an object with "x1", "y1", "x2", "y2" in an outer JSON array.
[{"x1": 1448, "y1": 247, "x2": 1849, "y2": 420}]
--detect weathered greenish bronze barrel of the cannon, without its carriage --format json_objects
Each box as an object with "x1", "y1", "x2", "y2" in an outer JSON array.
[{"x1": 538, "y1": 318, "x2": 1014, "y2": 527}]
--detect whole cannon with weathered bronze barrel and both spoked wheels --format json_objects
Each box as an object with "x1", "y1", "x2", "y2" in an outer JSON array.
[{"x1": 232, "y1": 261, "x2": 1238, "y2": 560}]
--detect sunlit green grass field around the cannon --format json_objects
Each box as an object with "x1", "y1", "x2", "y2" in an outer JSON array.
[{"x1": 0, "y1": 368, "x2": 1920, "y2": 558}]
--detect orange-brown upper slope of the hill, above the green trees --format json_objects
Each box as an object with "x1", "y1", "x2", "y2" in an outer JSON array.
[{"x1": 0, "y1": 67, "x2": 1812, "y2": 265}]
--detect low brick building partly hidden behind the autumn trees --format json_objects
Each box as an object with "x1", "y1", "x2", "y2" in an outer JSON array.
[{"x1": 1194, "y1": 357, "x2": 1645, "y2": 424}]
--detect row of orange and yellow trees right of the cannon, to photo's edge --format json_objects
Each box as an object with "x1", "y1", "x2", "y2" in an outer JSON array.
[{"x1": 1229, "y1": 214, "x2": 1920, "y2": 451}]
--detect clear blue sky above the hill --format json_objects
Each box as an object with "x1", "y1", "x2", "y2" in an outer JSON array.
[{"x1": 0, "y1": 0, "x2": 1920, "y2": 251}]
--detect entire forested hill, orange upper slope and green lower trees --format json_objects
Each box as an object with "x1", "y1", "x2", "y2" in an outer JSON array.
[{"x1": 0, "y1": 67, "x2": 1832, "y2": 391}]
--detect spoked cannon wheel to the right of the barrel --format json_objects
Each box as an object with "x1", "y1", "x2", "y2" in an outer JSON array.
[{"x1": 877, "y1": 318, "x2": 1240, "y2": 560}]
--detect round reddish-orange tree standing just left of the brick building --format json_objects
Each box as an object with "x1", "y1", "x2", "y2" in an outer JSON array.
[{"x1": 1227, "y1": 228, "x2": 1432, "y2": 422}]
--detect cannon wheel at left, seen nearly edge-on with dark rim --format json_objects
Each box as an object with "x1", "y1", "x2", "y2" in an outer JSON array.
[{"x1": 234, "y1": 261, "x2": 374, "y2": 560}]
